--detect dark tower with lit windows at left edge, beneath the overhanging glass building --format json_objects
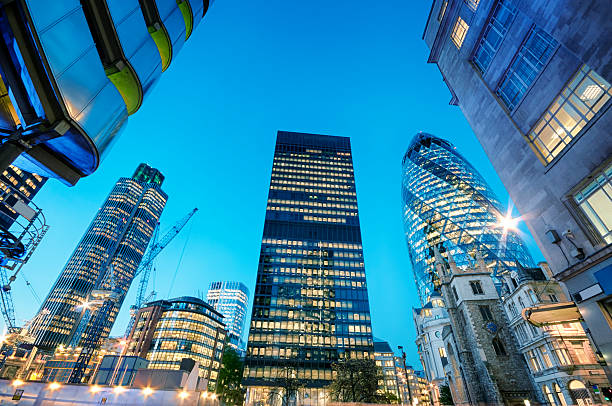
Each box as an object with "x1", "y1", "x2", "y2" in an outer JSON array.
[{"x1": 0, "y1": 165, "x2": 47, "y2": 230}]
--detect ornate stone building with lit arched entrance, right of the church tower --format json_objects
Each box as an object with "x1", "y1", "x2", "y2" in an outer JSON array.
[{"x1": 502, "y1": 263, "x2": 609, "y2": 406}]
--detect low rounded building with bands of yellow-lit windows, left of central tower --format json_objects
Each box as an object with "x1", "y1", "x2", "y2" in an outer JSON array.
[{"x1": 127, "y1": 297, "x2": 226, "y2": 386}]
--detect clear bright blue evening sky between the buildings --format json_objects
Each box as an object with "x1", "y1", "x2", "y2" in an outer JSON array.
[{"x1": 13, "y1": 0, "x2": 542, "y2": 365}]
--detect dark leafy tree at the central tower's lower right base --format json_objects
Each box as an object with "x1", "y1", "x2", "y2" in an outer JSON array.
[{"x1": 329, "y1": 358, "x2": 382, "y2": 403}]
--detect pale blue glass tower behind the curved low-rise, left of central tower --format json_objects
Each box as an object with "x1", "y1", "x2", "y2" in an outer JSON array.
[{"x1": 206, "y1": 281, "x2": 249, "y2": 351}]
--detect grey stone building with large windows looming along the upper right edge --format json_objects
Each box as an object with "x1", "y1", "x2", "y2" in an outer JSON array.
[{"x1": 423, "y1": 0, "x2": 612, "y2": 379}]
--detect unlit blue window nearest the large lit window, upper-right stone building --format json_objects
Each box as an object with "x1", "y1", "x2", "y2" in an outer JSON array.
[{"x1": 496, "y1": 27, "x2": 557, "y2": 110}]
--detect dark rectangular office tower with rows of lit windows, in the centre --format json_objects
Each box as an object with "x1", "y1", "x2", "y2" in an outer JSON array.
[{"x1": 244, "y1": 131, "x2": 374, "y2": 405}]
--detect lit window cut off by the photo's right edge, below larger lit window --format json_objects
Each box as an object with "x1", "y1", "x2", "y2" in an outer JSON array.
[{"x1": 574, "y1": 163, "x2": 612, "y2": 244}]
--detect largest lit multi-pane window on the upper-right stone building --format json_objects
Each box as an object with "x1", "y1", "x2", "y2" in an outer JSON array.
[{"x1": 529, "y1": 65, "x2": 612, "y2": 164}]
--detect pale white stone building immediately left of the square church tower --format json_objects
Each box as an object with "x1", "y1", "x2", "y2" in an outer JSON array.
[{"x1": 412, "y1": 292, "x2": 450, "y2": 387}]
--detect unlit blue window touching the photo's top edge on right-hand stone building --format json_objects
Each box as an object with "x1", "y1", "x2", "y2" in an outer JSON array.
[{"x1": 472, "y1": 0, "x2": 516, "y2": 73}]
